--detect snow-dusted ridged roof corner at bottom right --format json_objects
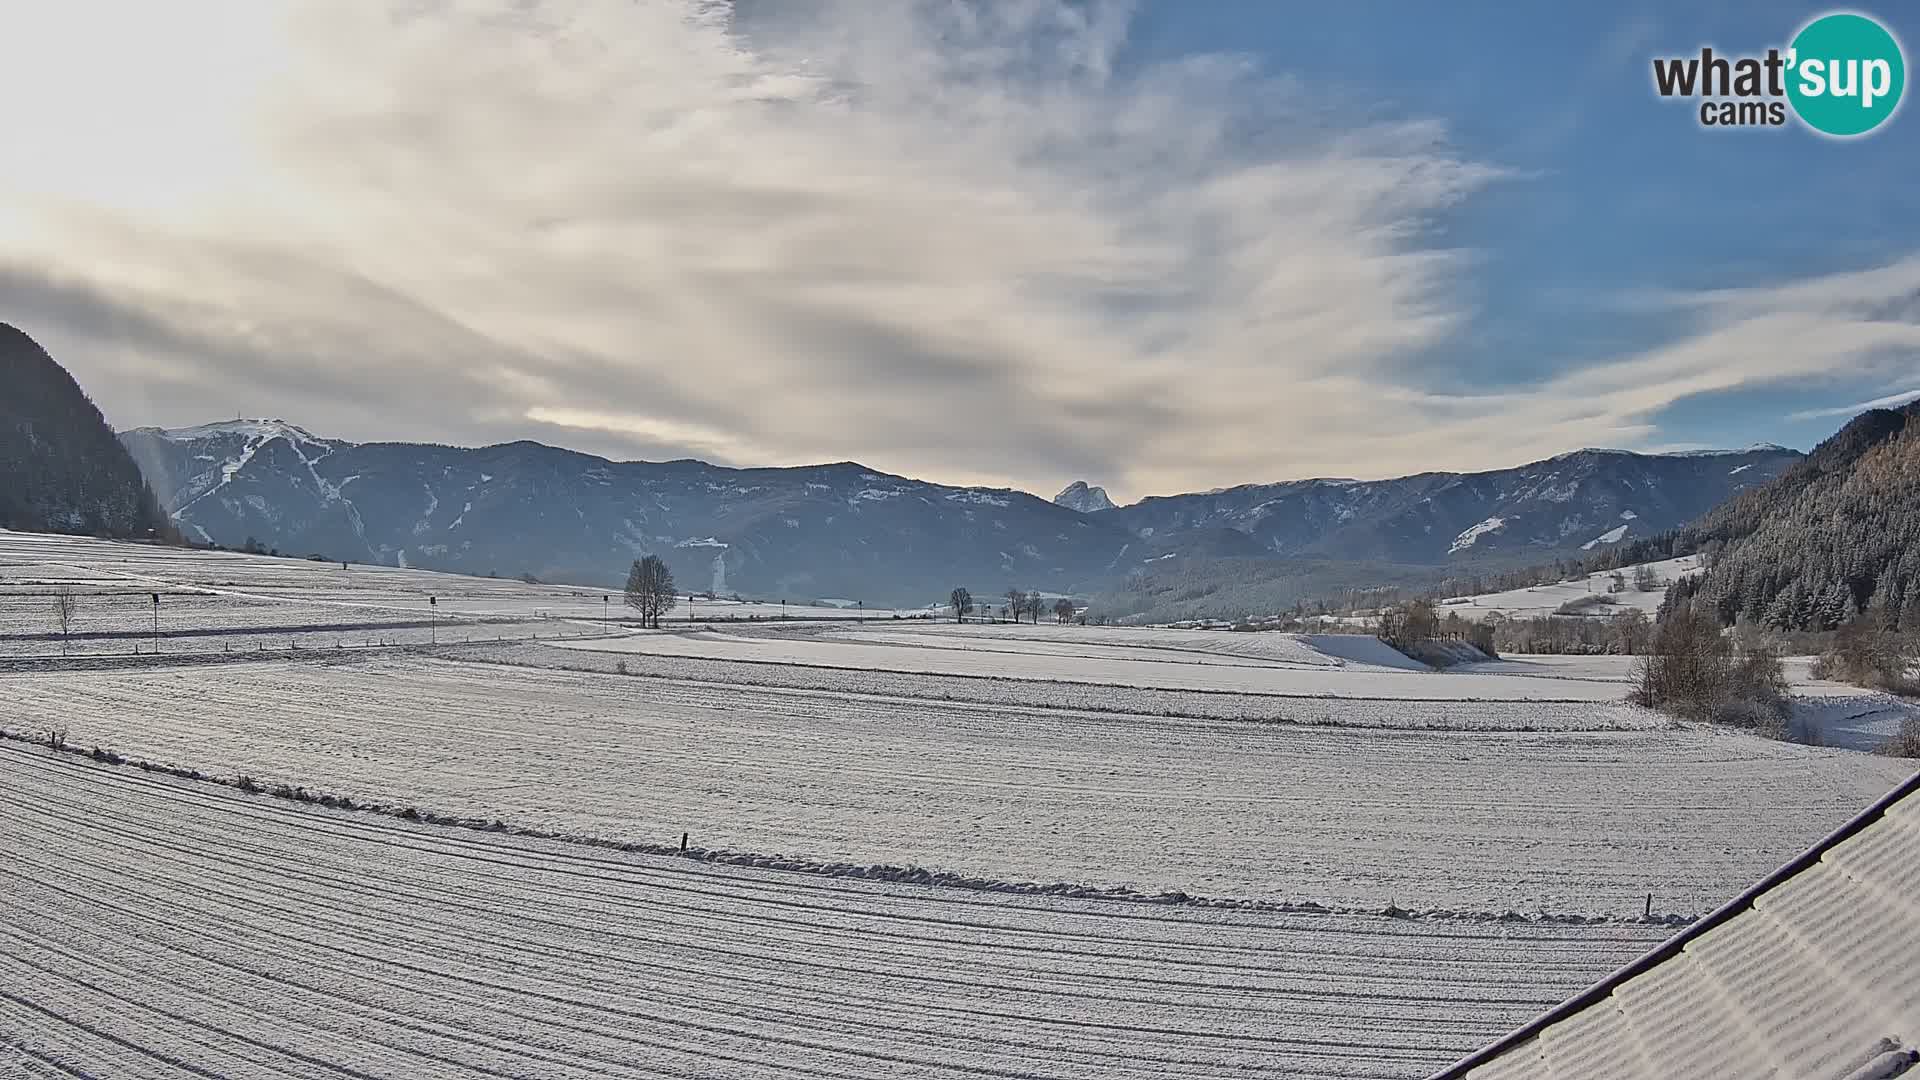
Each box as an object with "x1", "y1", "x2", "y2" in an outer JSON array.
[{"x1": 1434, "y1": 774, "x2": 1920, "y2": 1080}]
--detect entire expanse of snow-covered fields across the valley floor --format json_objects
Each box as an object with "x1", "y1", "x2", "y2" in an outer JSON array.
[{"x1": 0, "y1": 534, "x2": 1908, "y2": 1080}]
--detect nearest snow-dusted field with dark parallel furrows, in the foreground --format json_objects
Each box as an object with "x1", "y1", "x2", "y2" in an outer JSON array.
[{"x1": 0, "y1": 744, "x2": 1663, "y2": 1080}]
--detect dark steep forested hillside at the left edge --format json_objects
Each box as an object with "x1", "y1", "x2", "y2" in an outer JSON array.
[{"x1": 0, "y1": 323, "x2": 167, "y2": 536}]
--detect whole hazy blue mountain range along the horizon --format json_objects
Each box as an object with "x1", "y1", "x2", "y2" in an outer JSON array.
[{"x1": 121, "y1": 421, "x2": 1801, "y2": 605}]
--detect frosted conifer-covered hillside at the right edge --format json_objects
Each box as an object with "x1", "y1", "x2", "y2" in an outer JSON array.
[{"x1": 1674, "y1": 402, "x2": 1920, "y2": 630}]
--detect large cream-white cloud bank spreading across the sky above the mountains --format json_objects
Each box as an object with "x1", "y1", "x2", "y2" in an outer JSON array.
[{"x1": 0, "y1": 0, "x2": 1920, "y2": 496}]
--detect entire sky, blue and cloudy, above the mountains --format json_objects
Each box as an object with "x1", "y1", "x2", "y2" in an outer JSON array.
[{"x1": 0, "y1": 0, "x2": 1920, "y2": 502}]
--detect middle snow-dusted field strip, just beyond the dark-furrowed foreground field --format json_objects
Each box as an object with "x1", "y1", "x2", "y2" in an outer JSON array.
[{"x1": 0, "y1": 659, "x2": 1905, "y2": 915}]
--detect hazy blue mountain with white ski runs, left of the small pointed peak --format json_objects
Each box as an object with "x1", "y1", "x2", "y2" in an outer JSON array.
[{"x1": 121, "y1": 421, "x2": 1129, "y2": 603}]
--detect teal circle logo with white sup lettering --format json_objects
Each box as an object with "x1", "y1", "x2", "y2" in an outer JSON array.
[{"x1": 1788, "y1": 13, "x2": 1907, "y2": 138}]
